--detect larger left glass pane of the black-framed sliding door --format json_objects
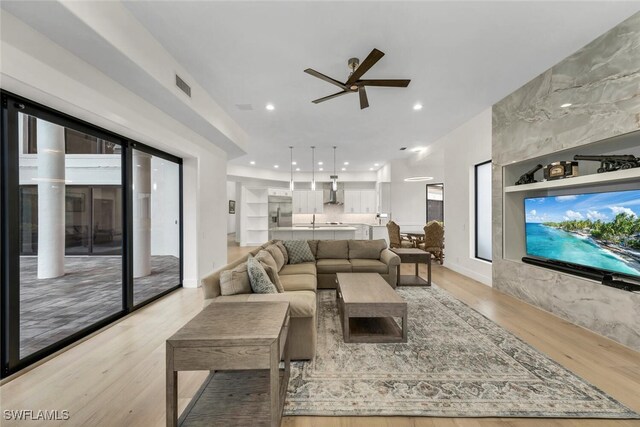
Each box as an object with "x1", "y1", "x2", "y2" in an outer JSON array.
[{"x1": 18, "y1": 113, "x2": 123, "y2": 359}]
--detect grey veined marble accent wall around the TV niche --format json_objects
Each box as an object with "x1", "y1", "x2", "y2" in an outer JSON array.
[{"x1": 492, "y1": 13, "x2": 640, "y2": 350}]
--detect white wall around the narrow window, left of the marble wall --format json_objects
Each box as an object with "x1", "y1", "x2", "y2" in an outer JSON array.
[{"x1": 391, "y1": 108, "x2": 491, "y2": 285}]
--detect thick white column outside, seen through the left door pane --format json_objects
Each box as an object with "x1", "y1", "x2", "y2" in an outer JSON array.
[{"x1": 37, "y1": 120, "x2": 65, "y2": 279}]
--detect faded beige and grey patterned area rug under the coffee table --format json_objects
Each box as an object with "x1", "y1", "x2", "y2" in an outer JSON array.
[{"x1": 284, "y1": 287, "x2": 640, "y2": 418}]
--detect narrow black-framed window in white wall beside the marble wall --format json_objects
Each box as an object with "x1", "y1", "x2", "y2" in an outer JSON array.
[{"x1": 475, "y1": 161, "x2": 492, "y2": 261}]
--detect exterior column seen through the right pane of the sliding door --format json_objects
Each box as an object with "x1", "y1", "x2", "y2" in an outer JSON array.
[{"x1": 133, "y1": 150, "x2": 151, "y2": 278}]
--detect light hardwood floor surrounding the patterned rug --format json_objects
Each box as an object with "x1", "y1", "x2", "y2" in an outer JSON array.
[{"x1": 0, "y1": 242, "x2": 640, "y2": 427}]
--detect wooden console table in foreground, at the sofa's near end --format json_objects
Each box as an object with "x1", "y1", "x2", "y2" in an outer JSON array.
[{"x1": 166, "y1": 302, "x2": 290, "y2": 427}]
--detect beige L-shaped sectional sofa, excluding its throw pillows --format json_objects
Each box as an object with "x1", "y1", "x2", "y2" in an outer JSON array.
[{"x1": 202, "y1": 240, "x2": 400, "y2": 360}]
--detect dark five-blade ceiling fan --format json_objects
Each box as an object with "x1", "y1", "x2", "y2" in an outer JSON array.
[{"x1": 304, "y1": 49, "x2": 411, "y2": 110}]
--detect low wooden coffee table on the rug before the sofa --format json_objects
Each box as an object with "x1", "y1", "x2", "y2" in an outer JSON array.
[{"x1": 336, "y1": 273, "x2": 407, "y2": 343}]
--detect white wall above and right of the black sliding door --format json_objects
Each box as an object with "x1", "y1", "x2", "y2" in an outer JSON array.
[{"x1": 0, "y1": 10, "x2": 234, "y2": 286}]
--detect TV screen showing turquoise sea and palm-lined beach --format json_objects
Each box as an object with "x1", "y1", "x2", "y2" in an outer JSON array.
[{"x1": 524, "y1": 190, "x2": 640, "y2": 276}]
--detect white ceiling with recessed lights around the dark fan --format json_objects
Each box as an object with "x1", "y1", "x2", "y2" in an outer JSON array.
[{"x1": 125, "y1": 1, "x2": 639, "y2": 171}]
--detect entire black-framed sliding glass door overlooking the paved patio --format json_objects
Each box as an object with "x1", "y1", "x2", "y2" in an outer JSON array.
[{"x1": 1, "y1": 93, "x2": 182, "y2": 377}]
